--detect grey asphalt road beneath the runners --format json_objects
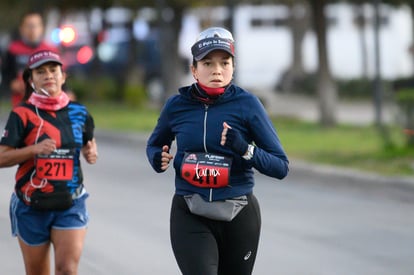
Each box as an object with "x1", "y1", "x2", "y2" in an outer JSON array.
[{"x1": 0, "y1": 137, "x2": 414, "y2": 275}]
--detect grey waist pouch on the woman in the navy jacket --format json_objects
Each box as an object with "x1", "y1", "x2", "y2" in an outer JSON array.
[{"x1": 184, "y1": 194, "x2": 248, "y2": 222}]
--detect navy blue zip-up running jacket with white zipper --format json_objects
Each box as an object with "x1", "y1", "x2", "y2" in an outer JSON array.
[{"x1": 147, "y1": 85, "x2": 289, "y2": 201}]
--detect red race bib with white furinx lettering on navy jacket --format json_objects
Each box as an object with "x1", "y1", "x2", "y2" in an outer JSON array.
[{"x1": 181, "y1": 153, "x2": 232, "y2": 188}]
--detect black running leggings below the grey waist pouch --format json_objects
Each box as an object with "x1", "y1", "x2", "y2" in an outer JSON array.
[{"x1": 170, "y1": 194, "x2": 261, "y2": 275}]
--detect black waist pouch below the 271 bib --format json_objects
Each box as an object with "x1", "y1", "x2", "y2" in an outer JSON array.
[{"x1": 30, "y1": 190, "x2": 73, "y2": 211}]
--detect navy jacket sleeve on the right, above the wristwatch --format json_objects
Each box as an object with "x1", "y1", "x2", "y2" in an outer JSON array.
[{"x1": 244, "y1": 97, "x2": 289, "y2": 179}]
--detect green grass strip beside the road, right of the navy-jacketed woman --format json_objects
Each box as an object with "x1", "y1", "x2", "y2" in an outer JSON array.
[{"x1": 274, "y1": 118, "x2": 414, "y2": 175}]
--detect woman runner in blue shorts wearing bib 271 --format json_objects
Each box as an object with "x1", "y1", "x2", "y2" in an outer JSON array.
[{"x1": 0, "y1": 50, "x2": 98, "y2": 275}]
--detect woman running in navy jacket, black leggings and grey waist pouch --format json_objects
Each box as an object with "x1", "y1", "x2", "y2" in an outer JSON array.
[{"x1": 147, "y1": 27, "x2": 289, "y2": 275}]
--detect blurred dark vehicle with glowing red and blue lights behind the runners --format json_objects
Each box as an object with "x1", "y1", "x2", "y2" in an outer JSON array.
[{"x1": 48, "y1": 7, "x2": 162, "y2": 97}]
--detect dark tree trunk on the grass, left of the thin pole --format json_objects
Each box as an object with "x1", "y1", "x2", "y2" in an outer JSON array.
[{"x1": 310, "y1": 0, "x2": 338, "y2": 126}]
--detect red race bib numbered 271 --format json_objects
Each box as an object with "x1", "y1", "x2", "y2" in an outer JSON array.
[{"x1": 36, "y1": 149, "x2": 74, "y2": 181}]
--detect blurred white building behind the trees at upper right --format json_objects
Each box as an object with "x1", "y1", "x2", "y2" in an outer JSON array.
[{"x1": 181, "y1": 3, "x2": 413, "y2": 89}]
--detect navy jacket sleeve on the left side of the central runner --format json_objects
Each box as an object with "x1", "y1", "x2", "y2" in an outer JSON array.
[{"x1": 146, "y1": 102, "x2": 174, "y2": 173}]
